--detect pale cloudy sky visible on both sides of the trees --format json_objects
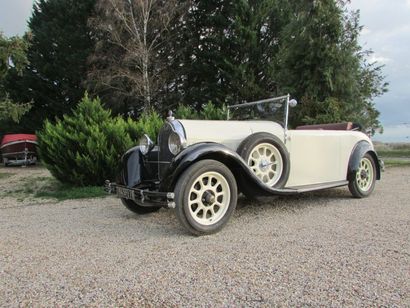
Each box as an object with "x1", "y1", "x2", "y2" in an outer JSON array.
[{"x1": 0, "y1": 0, "x2": 410, "y2": 142}]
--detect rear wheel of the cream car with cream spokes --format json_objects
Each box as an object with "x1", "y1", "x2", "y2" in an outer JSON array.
[{"x1": 349, "y1": 153, "x2": 376, "y2": 198}]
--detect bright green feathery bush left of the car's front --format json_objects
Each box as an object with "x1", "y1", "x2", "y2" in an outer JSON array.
[{"x1": 37, "y1": 94, "x2": 162, "y2": 186}]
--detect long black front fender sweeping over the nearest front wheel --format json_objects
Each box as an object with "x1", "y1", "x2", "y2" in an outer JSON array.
[{"x1": 160, "y1": 142, "x2": 295, "y2": 196}]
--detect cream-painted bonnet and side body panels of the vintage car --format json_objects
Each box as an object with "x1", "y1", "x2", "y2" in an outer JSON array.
[{"x1": 180, "y1": 120, "x2": 372, "y2": 187}]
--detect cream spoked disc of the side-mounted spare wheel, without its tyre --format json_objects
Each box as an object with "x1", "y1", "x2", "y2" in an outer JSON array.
[{"x1": 248, "y1": 143, "x2": 283, "y2": 187}]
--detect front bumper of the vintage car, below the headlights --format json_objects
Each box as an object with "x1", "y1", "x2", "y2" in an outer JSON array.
[{"x1": 104, "y1": 180, "x2": 175, "y2": 209}]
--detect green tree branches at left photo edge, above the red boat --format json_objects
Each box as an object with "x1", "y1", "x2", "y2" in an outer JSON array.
[{"x1": 0, "y1": 32, "x2": 31, "y2": 122}]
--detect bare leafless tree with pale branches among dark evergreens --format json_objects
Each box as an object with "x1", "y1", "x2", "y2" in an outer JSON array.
[{"x1": 88, "y1": 0, "x2": 188, "y2": 112}]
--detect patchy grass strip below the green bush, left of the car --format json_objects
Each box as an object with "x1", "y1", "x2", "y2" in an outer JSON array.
[{"x1": 4, "y1": 177, "x2": 107, "y2": 201}]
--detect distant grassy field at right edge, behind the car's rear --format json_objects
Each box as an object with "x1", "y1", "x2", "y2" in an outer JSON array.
[{"x1": 374, "y1": 142, "x2": 410, "y2": 166}]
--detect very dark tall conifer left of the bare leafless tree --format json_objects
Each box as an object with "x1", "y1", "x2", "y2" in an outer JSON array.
[{"x1": 8, "y1": 0, "x2": 95, "y2": 130}]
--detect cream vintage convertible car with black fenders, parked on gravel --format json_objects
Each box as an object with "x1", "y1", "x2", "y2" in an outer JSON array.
[{"x1": 106, "y1": 95, "x2": 382, "y2": 235}]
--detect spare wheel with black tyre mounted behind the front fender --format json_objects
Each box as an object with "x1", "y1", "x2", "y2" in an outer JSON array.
[{"x1": 238, "y1": 133, "x2": 289, "y2": 188}]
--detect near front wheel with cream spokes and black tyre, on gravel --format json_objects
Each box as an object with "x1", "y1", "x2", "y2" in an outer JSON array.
[{"x1": 175, "y1": 160, "x2": 238, "y2": 235}]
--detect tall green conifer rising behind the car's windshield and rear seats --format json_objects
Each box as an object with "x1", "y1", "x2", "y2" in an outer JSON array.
[{"x1": 277, "y1": 0, "x2": 387, "y2": 130}]
